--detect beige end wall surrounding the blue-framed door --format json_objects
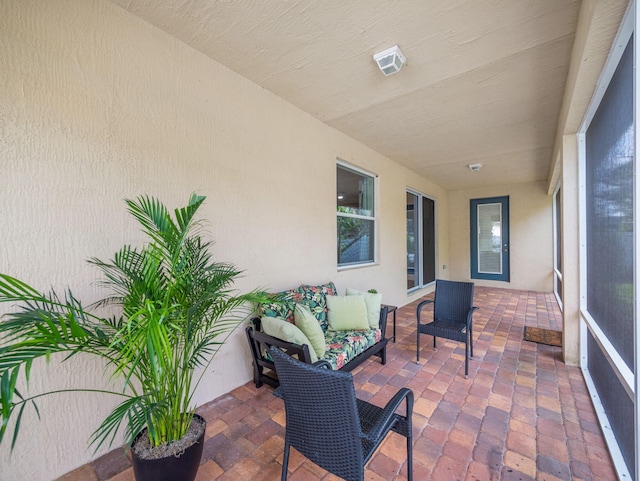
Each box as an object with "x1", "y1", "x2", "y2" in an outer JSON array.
[{"x1": 448, "y1": 182, "x2": 553, "y2": 292}]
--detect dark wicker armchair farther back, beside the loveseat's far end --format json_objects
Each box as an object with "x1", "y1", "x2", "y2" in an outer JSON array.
[{"x1": 416, "y1": 279, "x2": 477, "y2": 378}]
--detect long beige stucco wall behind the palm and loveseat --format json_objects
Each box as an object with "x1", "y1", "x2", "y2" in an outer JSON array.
[{"x1": 0, "y1": 0, "x2": 449, "y2": 481}]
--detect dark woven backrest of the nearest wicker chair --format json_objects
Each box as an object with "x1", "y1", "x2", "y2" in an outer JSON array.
[{"x1": 270, "y1": 347, "x2": 363, "y2": 479}]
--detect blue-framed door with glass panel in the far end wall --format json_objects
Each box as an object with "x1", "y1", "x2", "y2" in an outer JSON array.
[{"x1": 471, "y1": 196, "x2": 509, "y2": 282}]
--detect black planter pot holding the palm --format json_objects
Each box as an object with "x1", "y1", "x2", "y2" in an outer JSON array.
[{"x1": 131, "y1": 414, "x2": 206, "y2": 481}]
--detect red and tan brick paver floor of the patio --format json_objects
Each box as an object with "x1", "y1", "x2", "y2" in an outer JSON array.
[{"x1": 58, "y1": 287, "x2": 616, "y2": 481}]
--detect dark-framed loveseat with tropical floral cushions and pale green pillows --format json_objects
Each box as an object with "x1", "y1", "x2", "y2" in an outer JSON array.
[{"x1": 246, "y1": 282, "x2": 388, "y2": 387}]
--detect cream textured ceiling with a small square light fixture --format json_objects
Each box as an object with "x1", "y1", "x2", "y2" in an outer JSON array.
[{"x1": 111, "y1": 0, "x2": 580, "y2": 190}]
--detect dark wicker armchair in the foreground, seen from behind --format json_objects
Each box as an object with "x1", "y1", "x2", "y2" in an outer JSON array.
[{"x1": 270, "y1": 347, "x2": 413, "y2": 481}]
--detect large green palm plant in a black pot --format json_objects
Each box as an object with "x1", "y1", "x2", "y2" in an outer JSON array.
[{"x1": 0, "y1": 194, "x2": 265, "y2": 481}]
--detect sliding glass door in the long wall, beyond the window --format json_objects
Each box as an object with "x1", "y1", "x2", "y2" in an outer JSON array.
[{"x1": 407, "y1": 190, "x2": 436, "y2": 291}]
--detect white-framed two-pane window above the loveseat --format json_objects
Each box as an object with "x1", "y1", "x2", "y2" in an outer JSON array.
[{"x1": 337, "y1": 164, "x2": 376, "y2": 267}]
